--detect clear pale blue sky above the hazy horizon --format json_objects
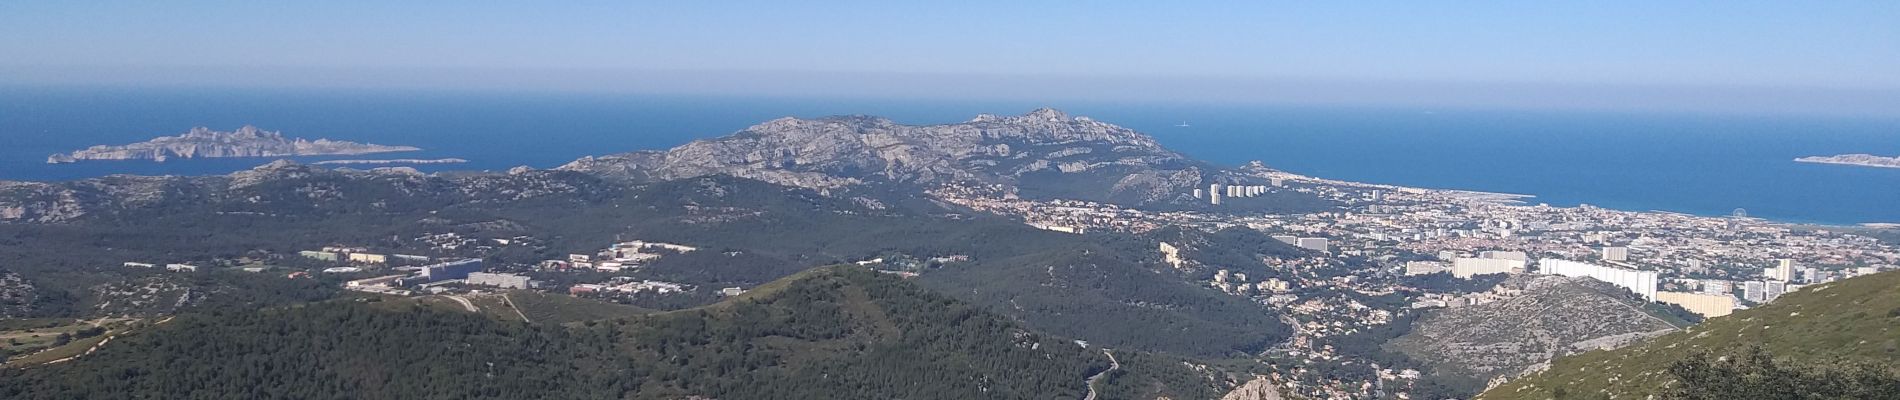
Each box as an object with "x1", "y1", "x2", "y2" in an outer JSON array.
[{"x1": 0, "y1": 0, "x2": 1900, "y2": 114}]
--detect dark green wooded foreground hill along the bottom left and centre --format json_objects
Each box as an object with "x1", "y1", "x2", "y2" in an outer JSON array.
[{"x1": 0, "y1": 267, "x2": 1229, "y2": 400}]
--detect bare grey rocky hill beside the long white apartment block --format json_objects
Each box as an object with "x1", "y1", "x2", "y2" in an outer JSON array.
[{"x1": 1387, "y1": 275, "x2": 1676, "y2": 381}]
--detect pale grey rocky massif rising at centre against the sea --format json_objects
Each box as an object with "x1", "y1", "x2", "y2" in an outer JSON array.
[{"x1": 561, "y1": 108, "x2": 1201, "y2": 203}]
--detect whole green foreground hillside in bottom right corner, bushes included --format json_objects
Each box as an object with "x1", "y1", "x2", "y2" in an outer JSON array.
[{"x1": 1478, "y1": 271, "x2": 1900, "y2": 400}]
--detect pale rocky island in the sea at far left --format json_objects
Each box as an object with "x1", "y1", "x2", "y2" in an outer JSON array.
[{"x1": 46, "y1": 125, "x2": 422, "y2": 163}]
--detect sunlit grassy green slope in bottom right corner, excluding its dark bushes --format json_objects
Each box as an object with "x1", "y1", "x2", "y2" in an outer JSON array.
[{"x1": 1478, "y1": 271, "x2": 1900, "y2": 400}]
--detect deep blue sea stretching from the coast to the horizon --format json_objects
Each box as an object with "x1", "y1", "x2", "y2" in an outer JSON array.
[{"x1": 0, "y1": 87, "x2": 1900, "y2": 224}]
